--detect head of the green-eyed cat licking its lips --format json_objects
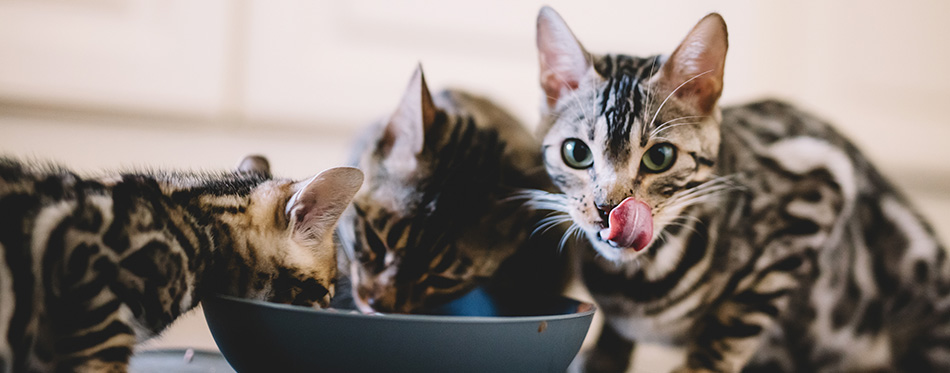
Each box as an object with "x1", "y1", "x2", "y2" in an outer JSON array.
[{"x1": 537, "y1": 7, "x2": 728, "y2": 262}]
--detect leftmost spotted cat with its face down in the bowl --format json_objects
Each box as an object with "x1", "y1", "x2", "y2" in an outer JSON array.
[{"x1": 0, "y1": 156, "x2": 362, "y2": 372}]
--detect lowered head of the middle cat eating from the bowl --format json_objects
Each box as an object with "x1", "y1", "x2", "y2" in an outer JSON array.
[{"x1": 340, "y1": 68, "x2": 502, "y2": 313}]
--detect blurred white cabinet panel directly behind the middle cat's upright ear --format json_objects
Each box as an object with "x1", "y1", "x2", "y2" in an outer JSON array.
[{"x1": 244, "y1": 0, "x2": 539, "y2": 128}]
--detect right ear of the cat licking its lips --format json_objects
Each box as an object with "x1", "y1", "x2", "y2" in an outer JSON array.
[{"x1": 657, "y1": 13, "x2": 729, "y2": 114}]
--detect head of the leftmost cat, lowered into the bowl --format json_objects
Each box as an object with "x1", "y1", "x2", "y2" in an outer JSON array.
[{"x1": 213, "y1": 156, "x2": 363, "y2": 307}]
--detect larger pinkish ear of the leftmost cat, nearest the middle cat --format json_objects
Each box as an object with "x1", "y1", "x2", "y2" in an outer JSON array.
[{"x1": 285, "y1": 167, "x2": 363, "y2": 244}]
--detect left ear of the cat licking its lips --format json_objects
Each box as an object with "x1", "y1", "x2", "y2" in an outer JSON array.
[{"x1": 537, "y1": 6, "x2": 591, "y2": 108}]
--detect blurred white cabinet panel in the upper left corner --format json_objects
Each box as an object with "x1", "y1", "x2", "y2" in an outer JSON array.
[{"x1": 0, "y1": 0, "x2": 231, "y2": 117}]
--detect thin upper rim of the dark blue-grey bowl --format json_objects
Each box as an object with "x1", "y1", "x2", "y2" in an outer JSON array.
[{"x1": 201, "y1": 294, "x2": 597, "y2": 324}]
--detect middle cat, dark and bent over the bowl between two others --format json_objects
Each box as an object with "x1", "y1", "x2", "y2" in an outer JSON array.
[{"x1": 339, "y1": 67, "x2": 567, "y2": 313}]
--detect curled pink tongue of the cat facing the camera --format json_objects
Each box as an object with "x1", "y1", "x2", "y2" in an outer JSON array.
[{"x1": 600, "y1": 197, "x2": 653, "y2": 251}]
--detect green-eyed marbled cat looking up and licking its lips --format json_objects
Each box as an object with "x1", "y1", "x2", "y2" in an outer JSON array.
[{"x1": 535, "y1": 7, "x2": 950, "y2": 372}]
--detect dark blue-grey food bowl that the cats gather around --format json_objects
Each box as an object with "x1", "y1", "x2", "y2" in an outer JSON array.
[{"x1": 203, "y1": 290, "x2": 594, "y2": 372}]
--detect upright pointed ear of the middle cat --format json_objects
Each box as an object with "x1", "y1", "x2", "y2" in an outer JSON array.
[{"x1": 382, "y1": 65, "x2": 436, "y2": 162}]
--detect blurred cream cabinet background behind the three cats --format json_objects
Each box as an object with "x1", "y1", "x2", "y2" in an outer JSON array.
[{"x1": 0, "y1": 0, "x2": 950, "y2": 370}]
